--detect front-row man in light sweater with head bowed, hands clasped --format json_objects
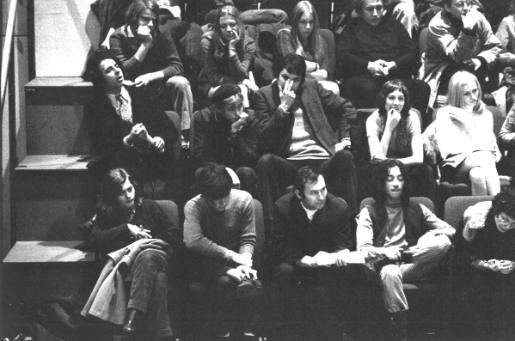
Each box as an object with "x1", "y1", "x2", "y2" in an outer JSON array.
[{"x1": 184, "y1": 164, "x2": 261, "y2": 337}]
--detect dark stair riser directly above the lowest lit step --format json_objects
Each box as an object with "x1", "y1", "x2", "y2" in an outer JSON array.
[{"x1": 14, "y1": 172, "x2": 97, "y2": 240}]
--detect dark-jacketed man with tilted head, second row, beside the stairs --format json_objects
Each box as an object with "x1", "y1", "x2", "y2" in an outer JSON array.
[{"x1": 85, "y1": 50, "x2": 178, "y2": 182}]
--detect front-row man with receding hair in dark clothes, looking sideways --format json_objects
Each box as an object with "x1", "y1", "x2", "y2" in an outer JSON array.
[{"x1": 268, "y1": 166, "x2": 358, "y2": 340}]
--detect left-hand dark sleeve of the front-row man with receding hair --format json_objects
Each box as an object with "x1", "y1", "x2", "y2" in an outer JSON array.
[{"x1": 271, "y1": 204, "x2": 305, "y2": 264}]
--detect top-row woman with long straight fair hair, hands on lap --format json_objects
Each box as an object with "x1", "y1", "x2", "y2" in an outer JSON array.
[{"x1": 277, "y1": 1, "x2": 340, "y2": 95}]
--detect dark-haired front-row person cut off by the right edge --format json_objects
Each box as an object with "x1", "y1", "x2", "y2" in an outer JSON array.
[{"x1": 463, "y1": 193, "x2": 515, "y2": 340}]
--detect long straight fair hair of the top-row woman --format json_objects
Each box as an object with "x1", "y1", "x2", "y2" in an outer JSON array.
[{"x1": 291, "y1": 0, "x2": 326, "y2": 61}]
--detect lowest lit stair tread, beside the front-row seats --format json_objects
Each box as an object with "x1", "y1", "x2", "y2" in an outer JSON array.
[{"x1": 4, "y1": 240, "x2": 96, "y2": 264}]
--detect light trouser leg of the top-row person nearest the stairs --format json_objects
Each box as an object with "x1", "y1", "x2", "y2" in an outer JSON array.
[{"x1": 166, "y1": 76, "x2": 193, "y2": 131}]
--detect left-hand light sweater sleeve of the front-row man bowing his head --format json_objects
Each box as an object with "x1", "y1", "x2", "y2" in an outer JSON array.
[{"x1": 184, "y1": 200, "x2": 229, "y2": 260}]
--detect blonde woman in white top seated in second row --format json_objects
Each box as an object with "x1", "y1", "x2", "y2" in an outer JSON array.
[{"x1": 424, "y1": 71, "x2": 501, "y2": 195}]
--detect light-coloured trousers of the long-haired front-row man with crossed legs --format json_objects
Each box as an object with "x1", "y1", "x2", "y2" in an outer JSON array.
[{"x1": 379, "y1": 233, "x2": 451, "y2": 313}]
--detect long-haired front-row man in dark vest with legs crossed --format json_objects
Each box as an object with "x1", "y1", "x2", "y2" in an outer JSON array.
[{"x1": 356, "y1": 160, "x2": 455, "y2": 340}]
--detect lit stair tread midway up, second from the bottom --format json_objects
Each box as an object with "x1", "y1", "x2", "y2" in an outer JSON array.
[{"x1": 16, "y1": 155, "x2": 98, "y2": 172}]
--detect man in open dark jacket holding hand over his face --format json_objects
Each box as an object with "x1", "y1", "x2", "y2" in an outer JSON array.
[{"x1": 255, "y1": 54, "x2": 357, "y2": 220}]
